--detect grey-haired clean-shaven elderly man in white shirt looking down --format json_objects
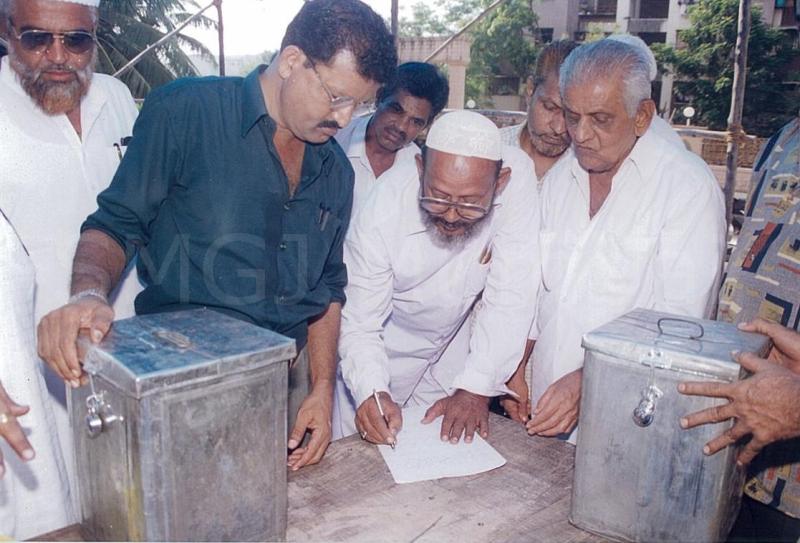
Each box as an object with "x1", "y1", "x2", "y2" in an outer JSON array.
[{"x1": 509, "y1": 39, "x2": 726, "y2": 442}]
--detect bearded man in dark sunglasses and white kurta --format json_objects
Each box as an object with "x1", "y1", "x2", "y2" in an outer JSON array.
[{"x1": 0, "y1": 0, "x2": 140, "y2": 535}]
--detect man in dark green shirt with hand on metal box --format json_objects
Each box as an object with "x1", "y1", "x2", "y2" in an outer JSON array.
[{"x1": 39, "y1": 0, "x2": 397, "y2": 469}]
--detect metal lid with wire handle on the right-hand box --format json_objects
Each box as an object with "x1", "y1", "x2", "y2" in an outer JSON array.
[{"x1": 582, "y1": 309, "x2": 771, "y2": 381}]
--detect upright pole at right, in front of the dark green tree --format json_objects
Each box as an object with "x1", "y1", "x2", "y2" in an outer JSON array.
[{"x1": 725, "y1": 0, "x2": 750, "y2": 238}]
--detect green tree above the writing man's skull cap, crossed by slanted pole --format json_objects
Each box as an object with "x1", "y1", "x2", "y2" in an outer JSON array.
[{"x1": 400, "y1": 0, "x2": 537, "y2": 106}]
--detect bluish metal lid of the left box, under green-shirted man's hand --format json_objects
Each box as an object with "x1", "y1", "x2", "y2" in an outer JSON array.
[{"x1": 84, "y1": 309, "x2": 296, "y2": 398}]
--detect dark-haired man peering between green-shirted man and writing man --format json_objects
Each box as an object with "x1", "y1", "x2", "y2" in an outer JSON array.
[{"x1": 335, "y1": 62, "x2": 450, "y2": 211}]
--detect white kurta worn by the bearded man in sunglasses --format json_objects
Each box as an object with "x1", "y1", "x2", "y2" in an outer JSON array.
[{"x1": 0, "y1": 57, "x2": 141, "y2": 520}]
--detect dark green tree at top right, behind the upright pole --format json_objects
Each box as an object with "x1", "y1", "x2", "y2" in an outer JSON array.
[{"x1": 653, "y1": 0, "x2": 800, "y2": 136}]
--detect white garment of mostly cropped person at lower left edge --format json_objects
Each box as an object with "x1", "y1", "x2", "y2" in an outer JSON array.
[{"x1": 0, "y1": 214, "x2": 73, "y2": 540}]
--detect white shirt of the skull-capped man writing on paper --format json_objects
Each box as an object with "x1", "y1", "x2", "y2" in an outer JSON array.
[{"x1": 339, "y1": 147, "x2": 540, "y2": 406}]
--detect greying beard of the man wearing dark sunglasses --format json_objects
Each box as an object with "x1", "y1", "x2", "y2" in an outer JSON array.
[{"x1": 8, "y1": 42, "x2": 97, "y2": 115}]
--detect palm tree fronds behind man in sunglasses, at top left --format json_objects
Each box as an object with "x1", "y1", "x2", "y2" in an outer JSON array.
[{"x1": 97, "y1": 0, "x2": 216, "y2": 98}]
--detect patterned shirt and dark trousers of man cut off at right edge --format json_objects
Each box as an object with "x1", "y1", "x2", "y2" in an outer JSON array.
[{"x1": 692, "y1": 114, "x2": 800, "y2": 541}]
